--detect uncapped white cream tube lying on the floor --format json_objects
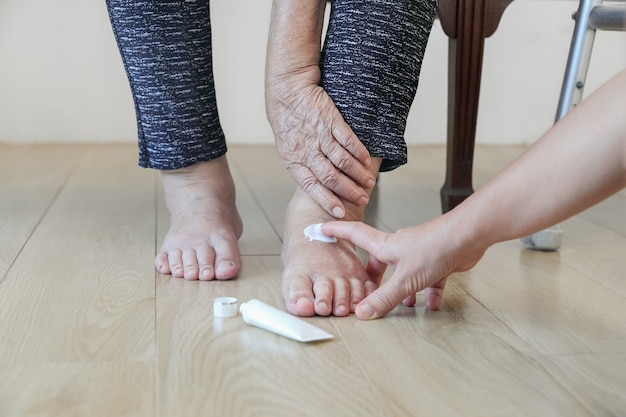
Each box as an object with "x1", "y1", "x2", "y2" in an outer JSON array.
[{"x1": 239, "y1": 299, "x2": 333, "y2": 342}]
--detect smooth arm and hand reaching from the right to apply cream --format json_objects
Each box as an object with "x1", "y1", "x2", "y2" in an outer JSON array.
[{"x1": 322, "y1": 71, "x2": 626, "y2": 319}]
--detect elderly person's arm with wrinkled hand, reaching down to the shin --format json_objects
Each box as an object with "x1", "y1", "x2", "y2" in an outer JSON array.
[{"x1": 265, "y1": 0, "x2": 375, "y2": 218}]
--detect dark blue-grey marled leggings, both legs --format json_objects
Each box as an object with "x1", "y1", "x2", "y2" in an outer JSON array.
[{"x1": 107, "y1": 0, "x2": 436, "y2": 171}]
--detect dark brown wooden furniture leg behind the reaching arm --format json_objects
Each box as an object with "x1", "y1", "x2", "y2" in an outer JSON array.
[{"x1": 438, "y1": 0, "x2": 513, "y2": 213}]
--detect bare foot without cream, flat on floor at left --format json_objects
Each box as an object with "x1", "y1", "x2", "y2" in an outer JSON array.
[{"x1": 155, "y1": 156, "x2": 243, "y2": 281}]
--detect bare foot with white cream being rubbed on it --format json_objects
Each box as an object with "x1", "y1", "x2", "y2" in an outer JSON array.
[{"x1": 281, "y1": 158, "x2": 381, "y2": 316}]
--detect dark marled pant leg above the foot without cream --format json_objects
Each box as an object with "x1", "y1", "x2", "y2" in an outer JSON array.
[{"x1": 107, "y1": 0, "x2": 226, "y2": 170}]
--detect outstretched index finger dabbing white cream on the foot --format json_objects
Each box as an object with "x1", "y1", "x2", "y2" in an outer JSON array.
[{"x1": 322, "y1": 221, "x2": 389, "y2": 261}]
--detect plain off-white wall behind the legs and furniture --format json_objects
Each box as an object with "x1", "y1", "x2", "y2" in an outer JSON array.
[{"x1": 0, "y1": 0, "x2": 626, "y2": 144}]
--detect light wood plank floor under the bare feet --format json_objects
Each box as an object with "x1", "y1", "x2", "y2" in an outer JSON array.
[{"x1": 0, "y1": 145, "x2": 626, "y2": 417}]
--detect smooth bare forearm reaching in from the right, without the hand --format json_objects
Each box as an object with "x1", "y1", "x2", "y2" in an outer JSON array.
[{"x1": 450, "y1": 71, "x2": 626, "y2": 247}]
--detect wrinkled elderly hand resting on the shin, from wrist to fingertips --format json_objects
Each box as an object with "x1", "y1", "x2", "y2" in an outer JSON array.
[{"x1": 267, "y1": 84, "x2": 376, "y2": 218}]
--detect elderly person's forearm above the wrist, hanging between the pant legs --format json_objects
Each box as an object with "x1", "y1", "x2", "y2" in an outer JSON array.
[{"x1": 265, "y1": 0, "x2": 326, "y2": 95}]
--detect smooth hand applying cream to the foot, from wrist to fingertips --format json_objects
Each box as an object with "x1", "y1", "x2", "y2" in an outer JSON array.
[{"x1": 322, "y1": 217, "x2": 486, "y2": 320}]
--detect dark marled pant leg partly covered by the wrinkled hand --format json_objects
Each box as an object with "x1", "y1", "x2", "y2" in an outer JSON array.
[{"x1": 321, "y1": 0, "x2": 436, "y2": 171}]
